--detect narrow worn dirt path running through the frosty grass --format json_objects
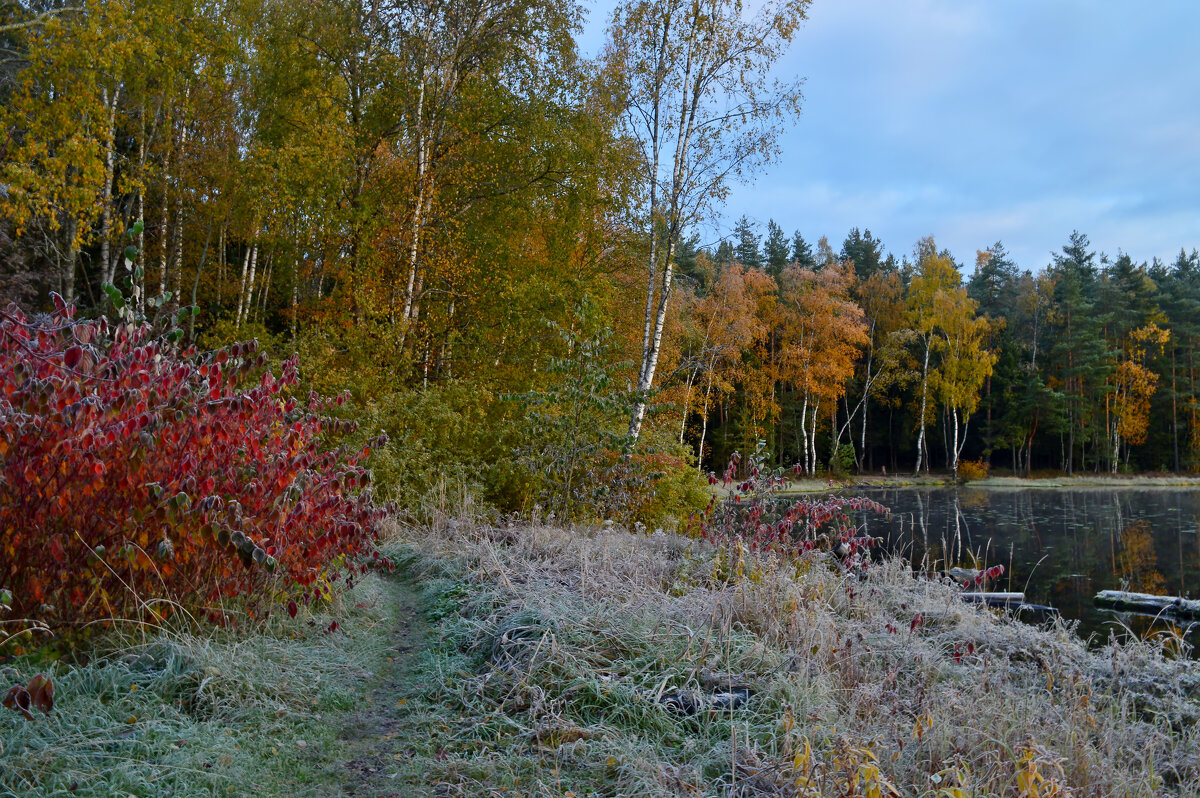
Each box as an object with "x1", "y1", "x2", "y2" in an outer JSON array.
[{"x1": 341, "y1": 580, "x2": 428, "y2": 798}]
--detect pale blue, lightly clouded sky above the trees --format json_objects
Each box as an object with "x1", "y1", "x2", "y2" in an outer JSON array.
[{"x1": 580, "y1": 0, "x2": 1200, "y2": 274}]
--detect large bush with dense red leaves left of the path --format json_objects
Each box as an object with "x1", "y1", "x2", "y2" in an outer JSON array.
[{"x1": 0, "y1": 296, "x2": 384, "y2": 638}]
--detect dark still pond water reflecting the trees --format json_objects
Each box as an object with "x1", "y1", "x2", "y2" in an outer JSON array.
[{"x1": 854, "y1": 487, "x2": 1200, "y2": 647}]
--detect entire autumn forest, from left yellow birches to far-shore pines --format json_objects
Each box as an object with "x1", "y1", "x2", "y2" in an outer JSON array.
[{"x1": 0, "y1": 0, "x2": 1200, "y2": 516}]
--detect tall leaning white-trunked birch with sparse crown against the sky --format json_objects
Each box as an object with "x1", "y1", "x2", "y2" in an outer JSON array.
[{"x1": 604, "y1": 0, "x2": 809, "y2": 440}]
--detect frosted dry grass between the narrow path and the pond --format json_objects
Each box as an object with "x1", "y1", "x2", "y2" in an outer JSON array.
[{"x1": 392, "y1": 511, "x2": 1200, "y2": 797}]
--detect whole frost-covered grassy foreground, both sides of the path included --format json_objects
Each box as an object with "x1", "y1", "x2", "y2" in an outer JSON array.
[{"x1": 9, "y1": 522, "x2": 1200, "y2": 798}]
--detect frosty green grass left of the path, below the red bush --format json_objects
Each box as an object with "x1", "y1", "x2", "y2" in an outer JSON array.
[{"x1": 0, "y1": 576, "x2": 400, "y2": 798}]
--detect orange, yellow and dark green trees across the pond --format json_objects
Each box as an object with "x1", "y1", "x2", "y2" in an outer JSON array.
[{"x1": 678, "y1": 217, "x2": 1200, "y2": 475}]
